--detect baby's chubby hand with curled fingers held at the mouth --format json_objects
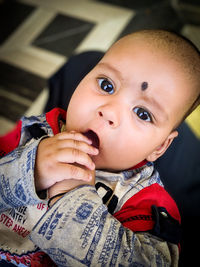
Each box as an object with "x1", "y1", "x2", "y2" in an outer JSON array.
[{"x1": 34, "y1": 132, "x2": 99, "y2": 191}]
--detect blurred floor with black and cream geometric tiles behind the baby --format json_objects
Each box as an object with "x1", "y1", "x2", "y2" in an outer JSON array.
[{"x1": 0, "y1": 0, "x2": 200, "y2": 136}]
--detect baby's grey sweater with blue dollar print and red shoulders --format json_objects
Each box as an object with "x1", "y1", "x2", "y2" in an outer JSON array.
[{"x1": 0, "y1": 109, "x2": 180, "y2": 266}]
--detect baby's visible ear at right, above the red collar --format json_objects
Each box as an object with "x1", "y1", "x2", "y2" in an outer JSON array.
[{"x1": 146, "y1": 131, "x2": 178, "y2": 161}]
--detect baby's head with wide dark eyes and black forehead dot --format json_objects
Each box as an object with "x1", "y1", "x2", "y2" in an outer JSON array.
[{"x1": 67, "y1": 30, "x2": 200, "y2": 170}]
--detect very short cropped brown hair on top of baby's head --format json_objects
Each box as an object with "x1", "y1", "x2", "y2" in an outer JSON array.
[{"x1": 130, "y1": 30, "x2": 200, "y2": 125}]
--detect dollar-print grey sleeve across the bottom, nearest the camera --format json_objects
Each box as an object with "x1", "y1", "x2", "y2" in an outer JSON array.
[{"x1": 31, "y1": 186, "x2": 178, "y2": 266}]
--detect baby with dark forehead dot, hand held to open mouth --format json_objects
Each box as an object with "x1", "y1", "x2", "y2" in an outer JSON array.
[{"x1": 0, "y1": 30, "x2": 200, "y2": 266}]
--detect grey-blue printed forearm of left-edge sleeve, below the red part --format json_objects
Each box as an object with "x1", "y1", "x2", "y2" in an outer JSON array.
[{"x1": 0, "y1": 139, "x2": 46, "y2": 211}]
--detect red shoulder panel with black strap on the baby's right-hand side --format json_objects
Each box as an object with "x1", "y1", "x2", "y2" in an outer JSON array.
[{"x1": 114, "y1": 183, "x2": 181, "y2": 244}]
